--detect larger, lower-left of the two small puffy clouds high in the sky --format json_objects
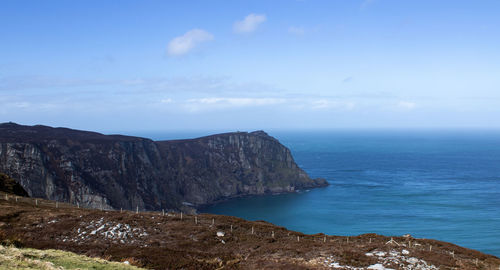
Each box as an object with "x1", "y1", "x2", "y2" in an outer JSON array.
[{"x1": 167, "y1": 29, "x2": 214, "y2": 56}]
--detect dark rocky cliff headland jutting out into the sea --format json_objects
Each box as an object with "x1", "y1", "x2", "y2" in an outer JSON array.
[{"x1": 0, "y1": 123, "x2": 327, "y2": 210}]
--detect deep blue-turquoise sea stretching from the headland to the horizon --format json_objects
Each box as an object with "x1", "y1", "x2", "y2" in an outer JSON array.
[{"x1": 136, "y1": 130, "x2": 500, "y2": 257}]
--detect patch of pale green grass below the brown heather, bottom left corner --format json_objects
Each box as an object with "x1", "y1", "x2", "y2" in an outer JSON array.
[{"x1": 0, "y1": 245, "x2": 145, "y2": 270}]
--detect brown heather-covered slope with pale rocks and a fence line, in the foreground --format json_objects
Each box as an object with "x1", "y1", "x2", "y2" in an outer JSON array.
[{"x1": 0, "y1": 191, "x2": 500, "y2": 270}]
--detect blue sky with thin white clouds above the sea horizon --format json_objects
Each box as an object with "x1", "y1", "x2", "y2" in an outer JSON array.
[{"x1": 0, "y1": 0, "x2": 500, "y2": 132}]
